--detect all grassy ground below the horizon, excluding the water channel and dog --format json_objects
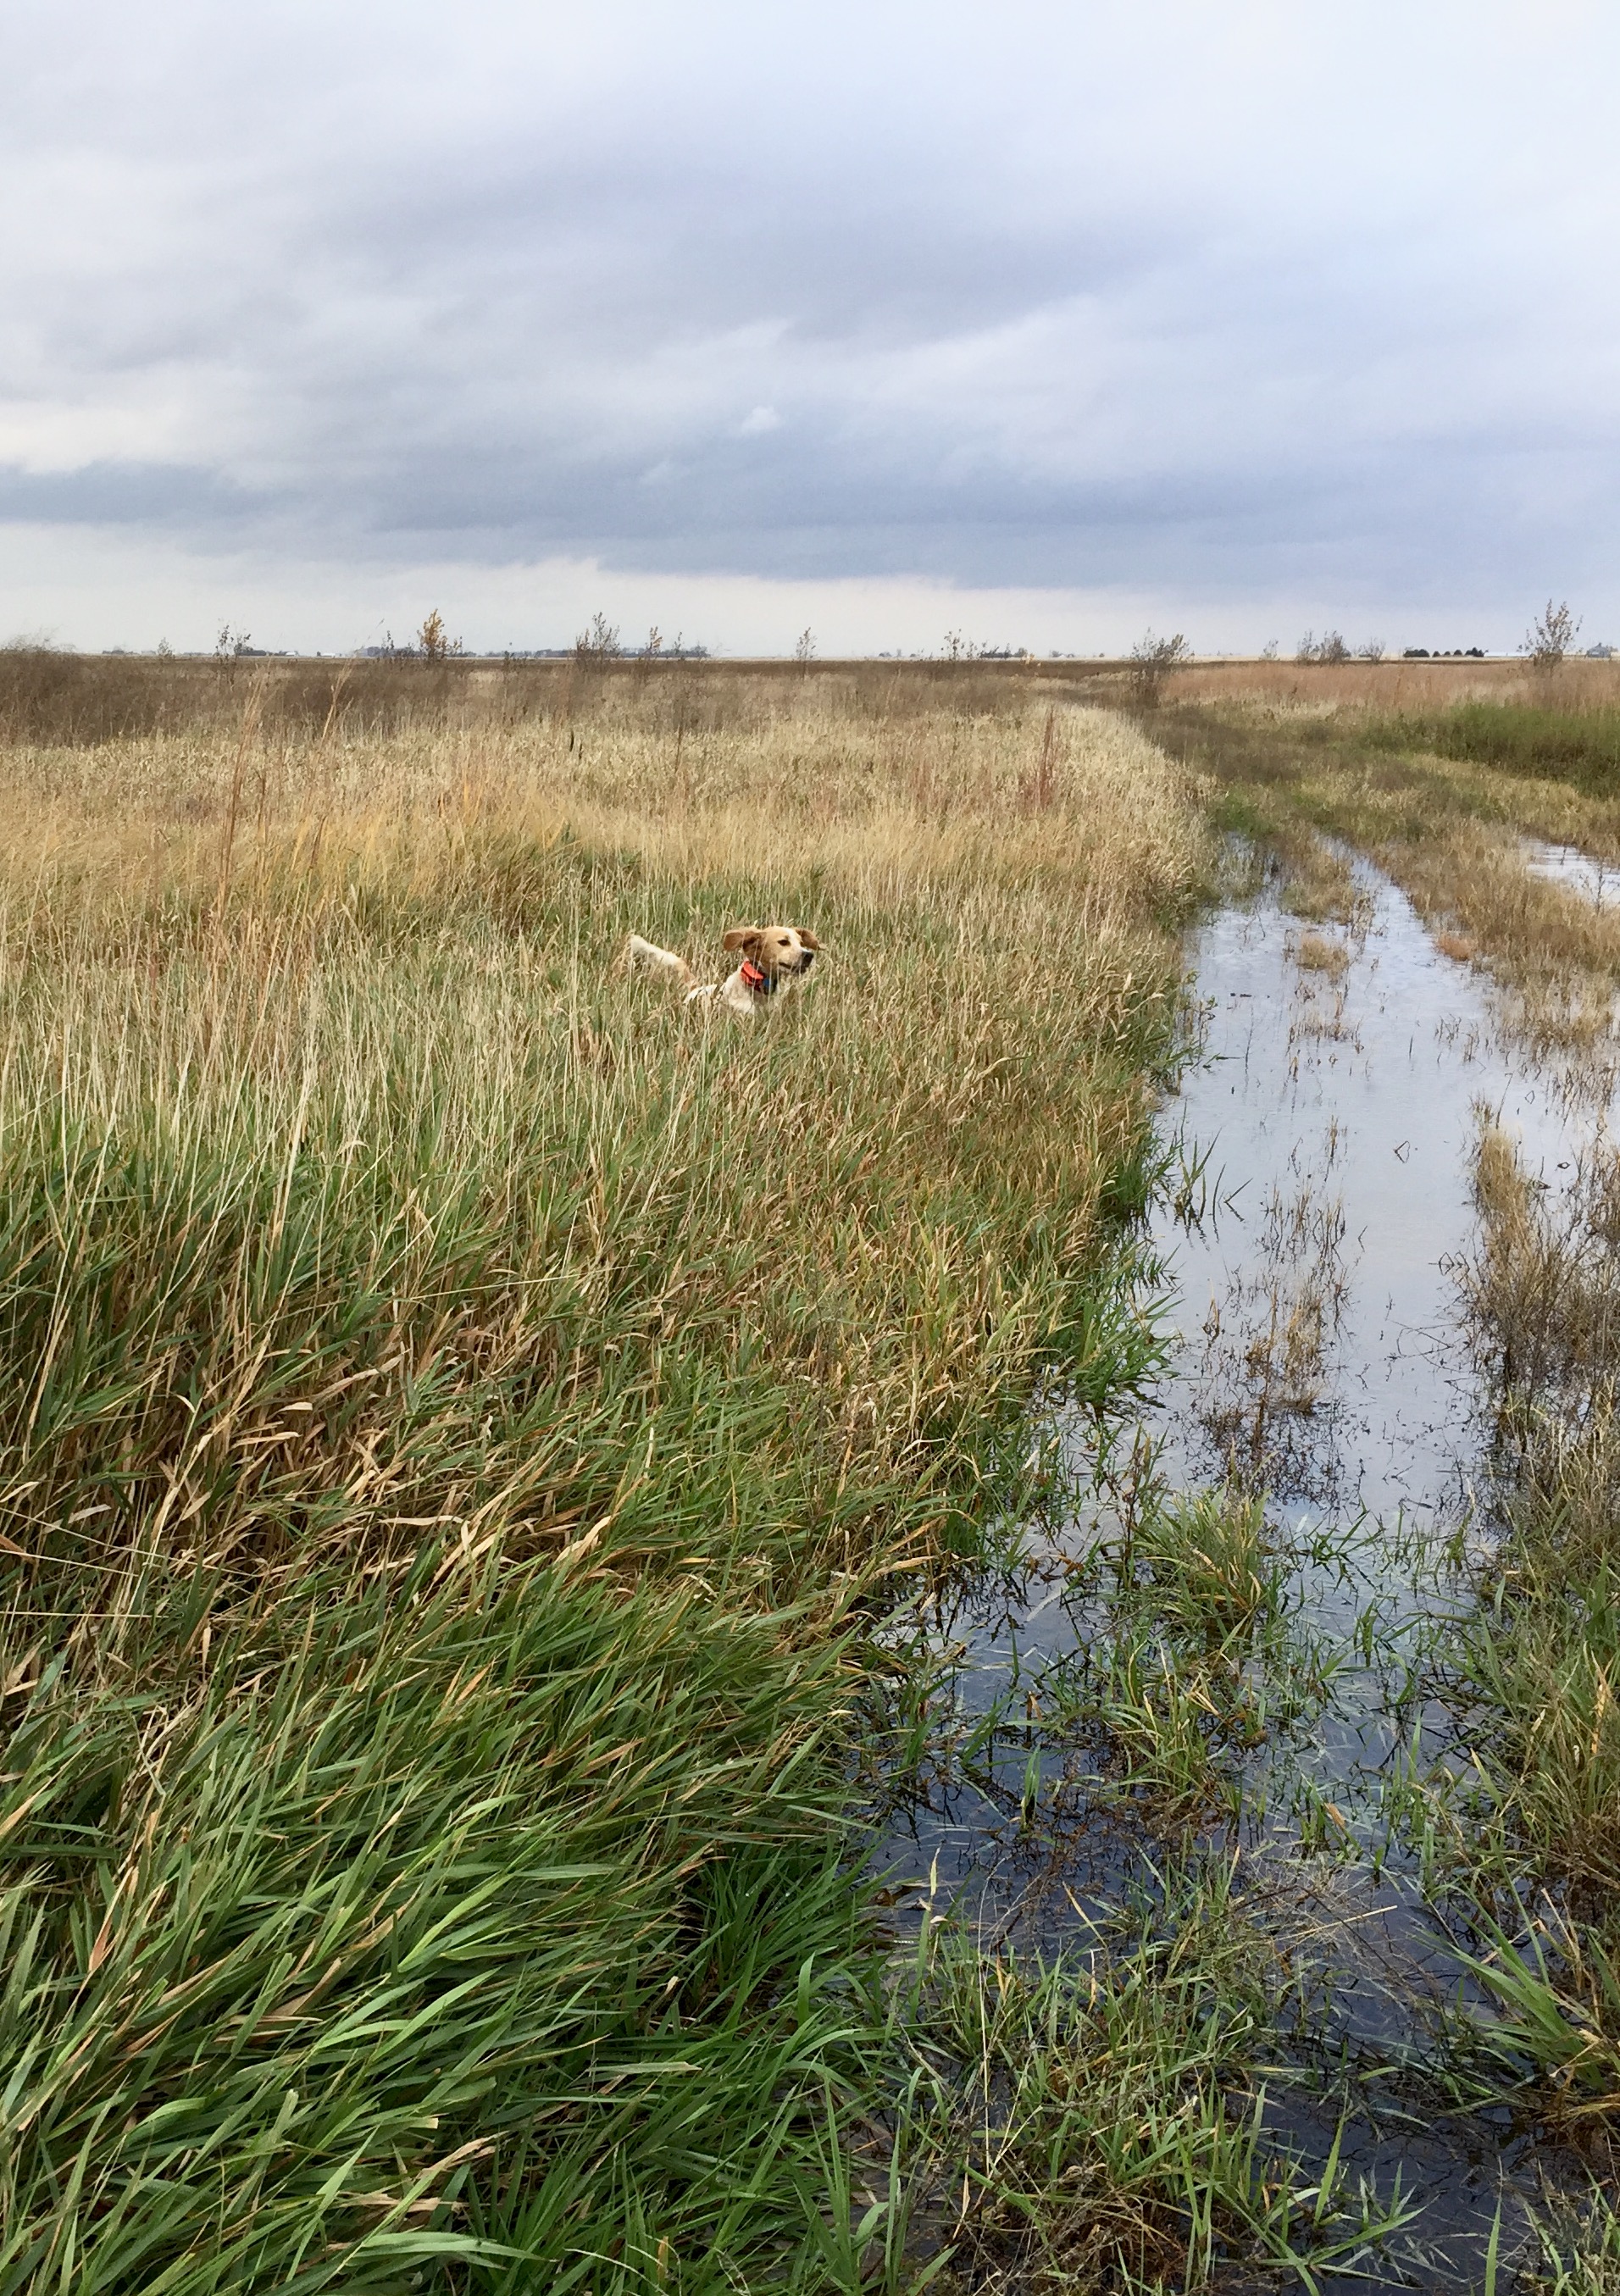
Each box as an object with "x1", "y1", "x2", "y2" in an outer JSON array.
[{"x1": 0, "y1": 654, "x2": 1620, "y2": 2296}]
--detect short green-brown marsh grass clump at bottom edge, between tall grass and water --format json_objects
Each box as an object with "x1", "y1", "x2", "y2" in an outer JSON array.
[{"x1": 876, "y1": 1869, "x2": 1402, "y2": 2292}]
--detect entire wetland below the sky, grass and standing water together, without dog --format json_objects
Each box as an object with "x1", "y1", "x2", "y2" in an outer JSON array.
[{"x1": 0, "y1": 663, "x2": 1620, "y2": 2296}]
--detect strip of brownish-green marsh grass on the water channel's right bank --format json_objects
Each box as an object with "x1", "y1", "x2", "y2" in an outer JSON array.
[{"x1": 1368, "y1": 1118, "x2": 1620, "y2": 2139}]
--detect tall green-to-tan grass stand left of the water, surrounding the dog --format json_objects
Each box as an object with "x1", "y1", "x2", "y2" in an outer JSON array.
[{"x1": 0, "y1": 679, "x2": 1220, "y2": 2296}]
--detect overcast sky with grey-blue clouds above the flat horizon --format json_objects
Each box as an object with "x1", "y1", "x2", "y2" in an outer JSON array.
[{"x1": 0, "y1": 0, "x2": 1620, "y2": 652}]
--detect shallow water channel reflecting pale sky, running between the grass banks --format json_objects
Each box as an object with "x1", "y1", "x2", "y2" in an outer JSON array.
[{"x1": 863, "y1": 863, "x2": 1593, "y2": 2292}]
